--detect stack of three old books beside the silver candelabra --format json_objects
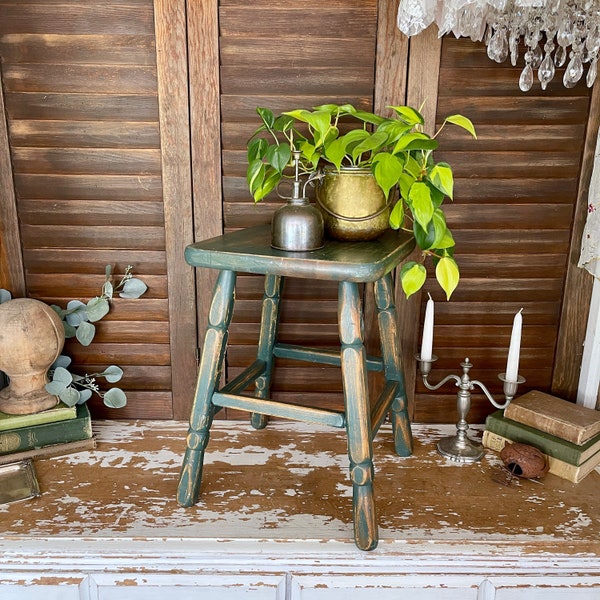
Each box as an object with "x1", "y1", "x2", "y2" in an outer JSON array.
[{"x1": 482, "y1": 391, "x2": 600, "y2": 483}]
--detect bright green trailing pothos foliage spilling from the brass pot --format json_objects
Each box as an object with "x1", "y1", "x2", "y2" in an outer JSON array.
[{"x1": 246, "y1": 104, "x2": 477, "y2": 299}]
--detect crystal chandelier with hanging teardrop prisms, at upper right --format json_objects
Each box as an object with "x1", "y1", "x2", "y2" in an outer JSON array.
[{"x1": 398, "y1": 0, "x2": 600, "y2": 92}]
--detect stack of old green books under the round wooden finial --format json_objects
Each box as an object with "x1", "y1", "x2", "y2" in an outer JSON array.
[{"x1": 0, "y1": 403, "x2": 96, "y2": 465}]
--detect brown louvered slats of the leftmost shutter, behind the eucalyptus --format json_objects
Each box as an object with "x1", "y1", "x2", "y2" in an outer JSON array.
[{"x1": 0, "y1": 0, "x2": 173, "y2": 418}]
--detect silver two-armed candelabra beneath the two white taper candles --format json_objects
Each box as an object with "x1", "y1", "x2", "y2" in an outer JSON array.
[{"x1": 416, "y1": 354, "x2": 525, "y2": 463}]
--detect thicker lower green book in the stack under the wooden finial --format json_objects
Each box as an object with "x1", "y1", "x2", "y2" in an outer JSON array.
[{"x1": 0, "y1": 403, "x2": 92, "y2": 456}]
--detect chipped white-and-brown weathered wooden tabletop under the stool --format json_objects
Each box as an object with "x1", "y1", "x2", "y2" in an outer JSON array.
[{"x1": 0, "y1": 421, "x2": 600, "y2": 557}]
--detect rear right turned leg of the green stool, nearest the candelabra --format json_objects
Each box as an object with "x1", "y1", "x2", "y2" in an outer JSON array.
[{"x1": 374, "y1": 273, "x2": 413, "y2": 456}]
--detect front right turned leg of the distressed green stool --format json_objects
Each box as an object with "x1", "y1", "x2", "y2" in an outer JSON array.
[{"x1": 338, "y1": 281, "x2": 378, "y2": 550}]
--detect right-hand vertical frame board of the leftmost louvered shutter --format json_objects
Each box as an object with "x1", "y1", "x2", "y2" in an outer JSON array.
[{"x1": 154, "y1": 0, "x2": 197, "y2": 419}]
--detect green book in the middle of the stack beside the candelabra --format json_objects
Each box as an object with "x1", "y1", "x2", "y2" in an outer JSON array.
[{"x1": 485, "y1": 410, "x2": 600, "y2": 466}]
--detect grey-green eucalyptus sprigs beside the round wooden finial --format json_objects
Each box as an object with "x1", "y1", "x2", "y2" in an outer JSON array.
[{"x1": 0, "y1": 265, "x2": 148, "y2": 408}]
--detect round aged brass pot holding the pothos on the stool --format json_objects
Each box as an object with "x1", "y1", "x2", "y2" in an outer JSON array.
[{"x1": 316, "y1": 168, "x2": 391, "y2": 241}]
